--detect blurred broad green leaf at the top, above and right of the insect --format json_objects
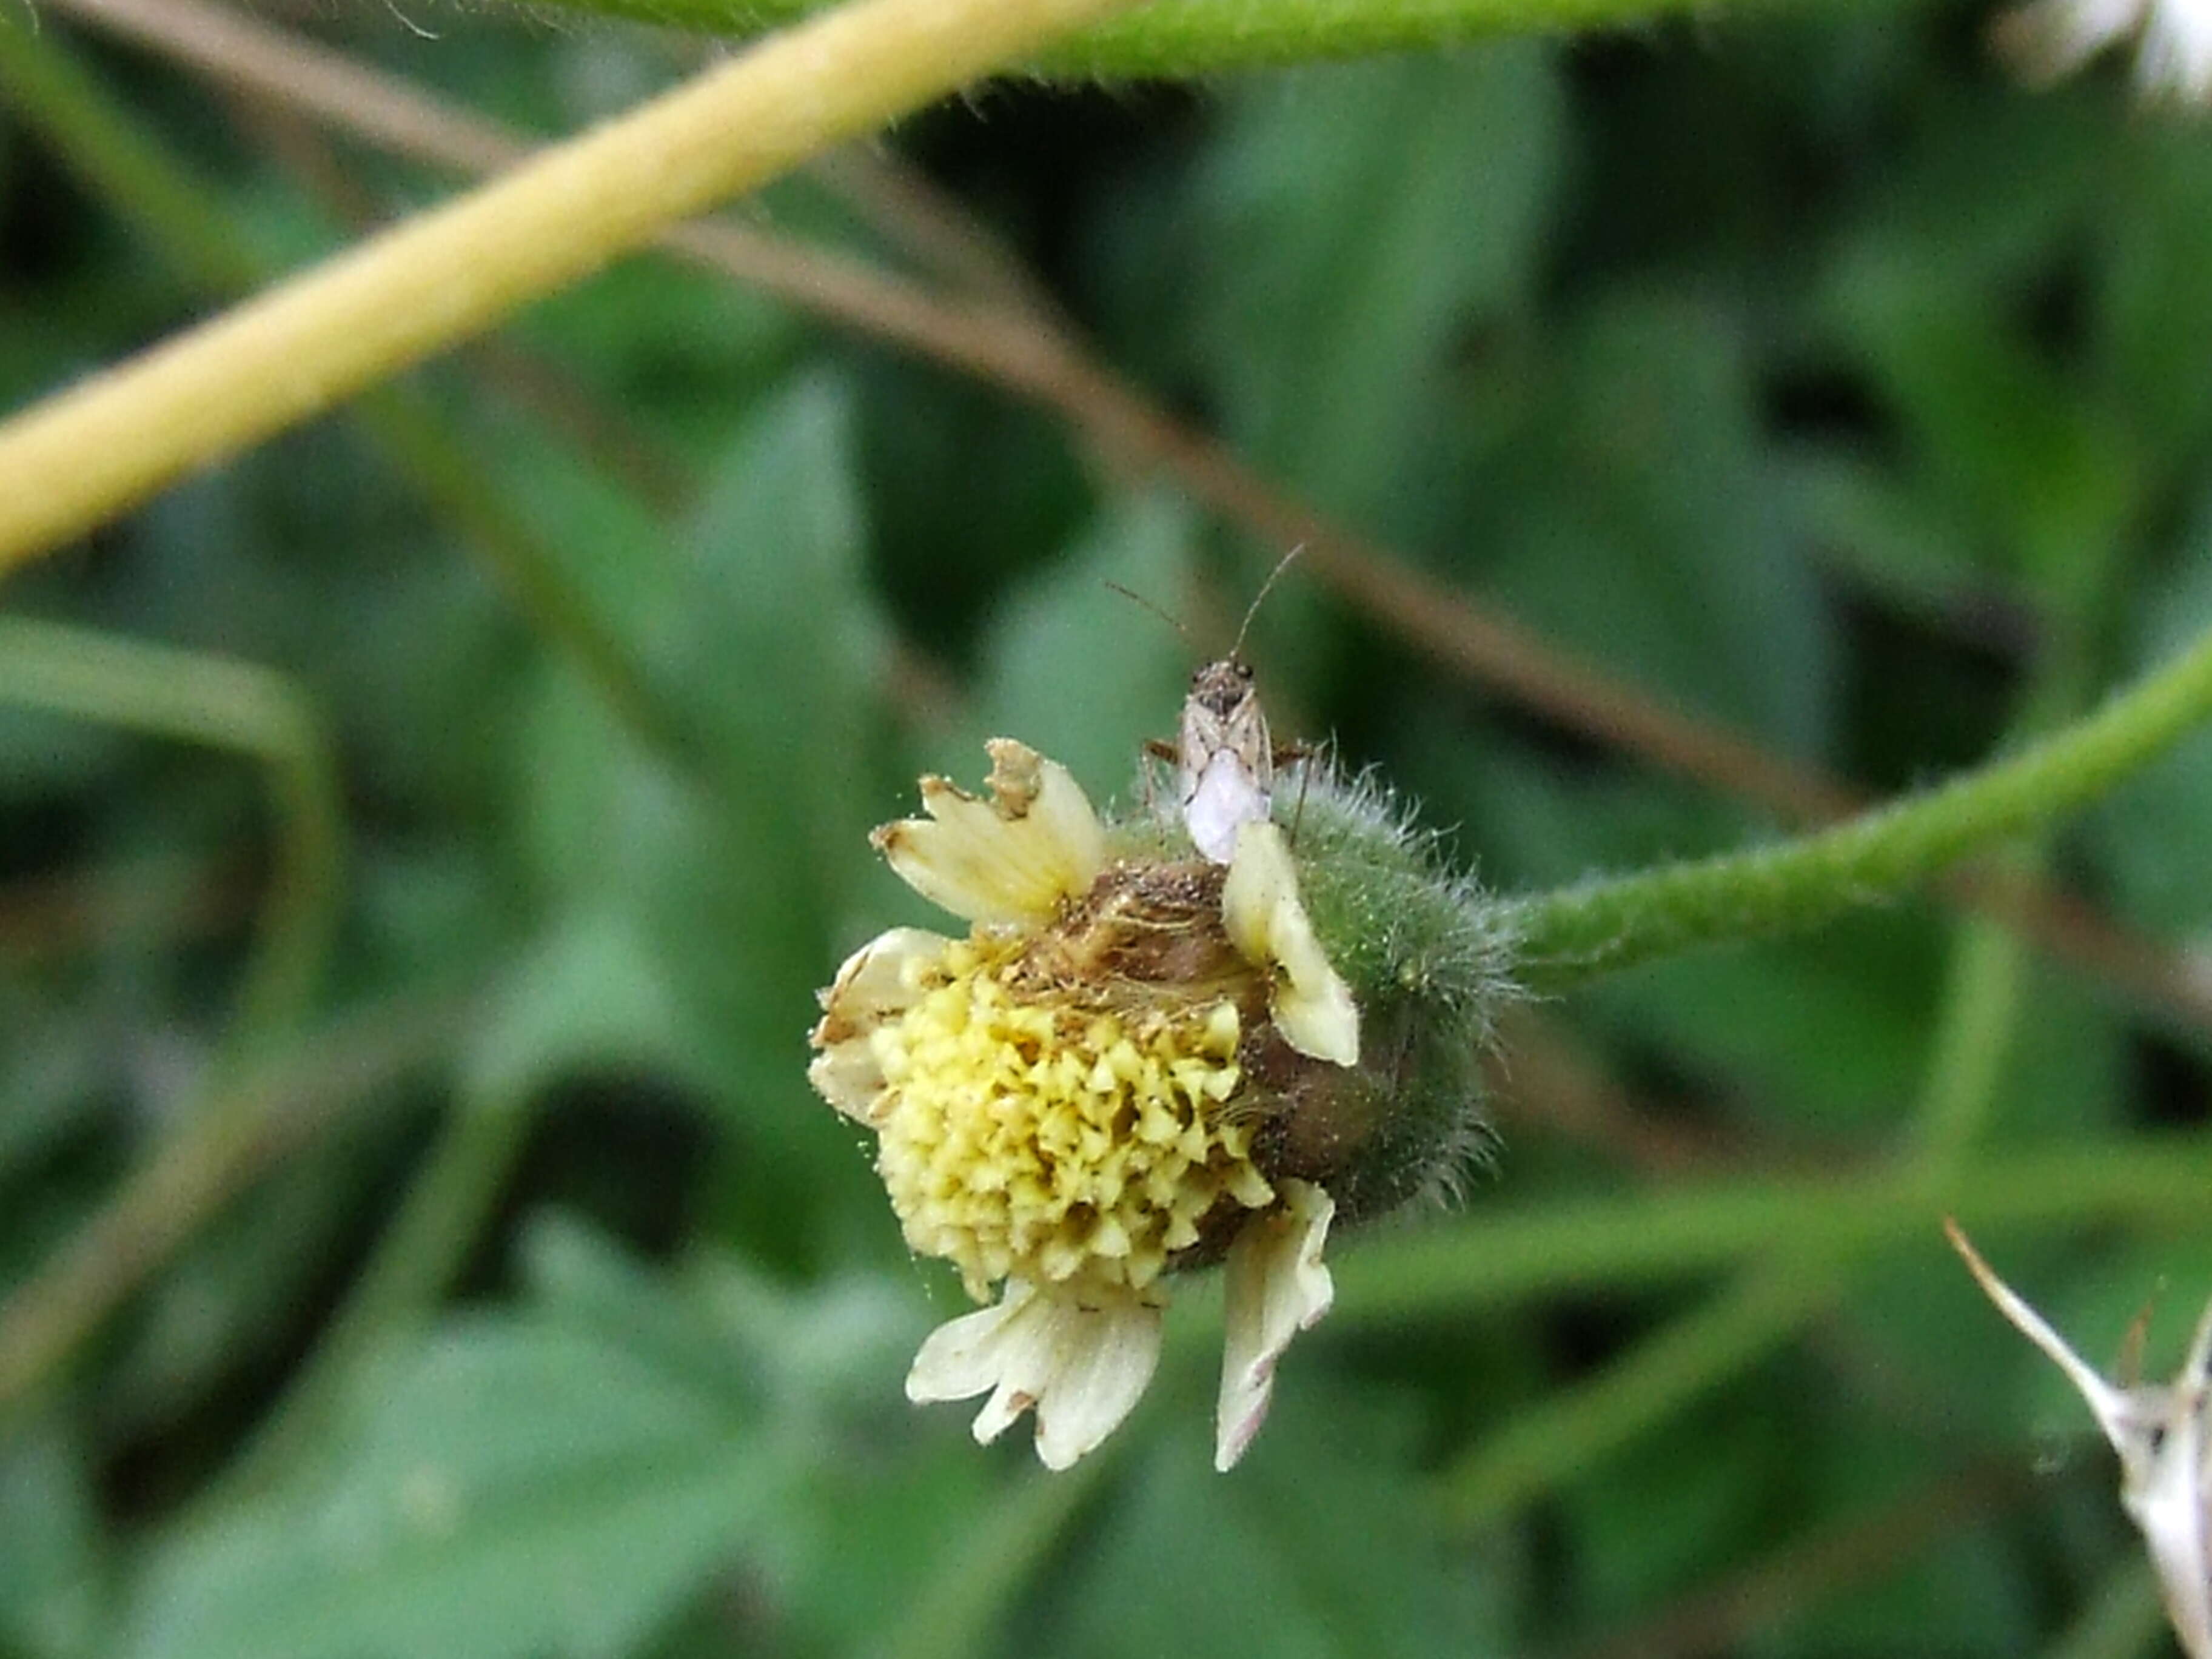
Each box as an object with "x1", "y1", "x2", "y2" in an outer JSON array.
[{"x1": 1190, "y1": 42, "x2": 1564, "y2": 531}]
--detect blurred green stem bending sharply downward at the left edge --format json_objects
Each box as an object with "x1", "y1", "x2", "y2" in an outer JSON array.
[{"x1": 0, "y1": 617, "x2": 345, "y2": 1053}]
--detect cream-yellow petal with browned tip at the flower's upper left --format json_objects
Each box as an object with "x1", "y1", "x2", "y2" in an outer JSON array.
[{"x1": 874, "y1": 737, "x2": 1106, "y2": 925}]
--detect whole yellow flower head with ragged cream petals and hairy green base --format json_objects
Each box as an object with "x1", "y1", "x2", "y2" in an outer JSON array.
[{"x1": 809, "y1": 739, "x2": 1502, "y2": 1469}]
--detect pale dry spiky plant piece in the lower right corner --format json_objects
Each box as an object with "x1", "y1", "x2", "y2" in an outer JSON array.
[{"x1": 1945, "y1": 1219, "x2": 2212, "y2": 1659}]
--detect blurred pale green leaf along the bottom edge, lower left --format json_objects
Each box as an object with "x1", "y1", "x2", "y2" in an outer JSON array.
[{"x1": 122, "y1": 1238, "x2": 792, "y2": 1659}]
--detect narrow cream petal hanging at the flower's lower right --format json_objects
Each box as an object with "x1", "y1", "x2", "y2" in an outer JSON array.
[{"x1": 1215, "y1": 1181, "x2": 1336, "y2": 1473}]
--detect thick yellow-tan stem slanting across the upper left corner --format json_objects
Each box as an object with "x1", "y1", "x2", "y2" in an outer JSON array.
[{"x1": 0, "y1": 0, "x2": 1130, "y2": 571}]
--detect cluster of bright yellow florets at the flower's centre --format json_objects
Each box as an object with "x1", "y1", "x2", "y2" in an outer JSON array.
[{"x1": 871, "y1": 938, "x2": 1274, "y2": 1298}]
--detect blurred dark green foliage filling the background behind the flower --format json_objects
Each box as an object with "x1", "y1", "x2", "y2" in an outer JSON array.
[{"x1": 0, "y1": 7, "x2": 2212, "y2": 1659}]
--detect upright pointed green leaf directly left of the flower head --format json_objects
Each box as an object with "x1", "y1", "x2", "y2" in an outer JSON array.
[{"x1": 526, "y1": 380, "x2": 876, "y2": 1134}]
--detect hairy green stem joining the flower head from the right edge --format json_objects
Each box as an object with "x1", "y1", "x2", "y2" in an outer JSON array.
[{"x1": 1511, "y1": 632, "x2": 2212, "y2": 991}]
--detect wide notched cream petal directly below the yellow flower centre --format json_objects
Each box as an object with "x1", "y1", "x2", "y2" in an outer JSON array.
[{"x1": 907, "y1": 1279, "x2": 1159, "y2": 1469}]
